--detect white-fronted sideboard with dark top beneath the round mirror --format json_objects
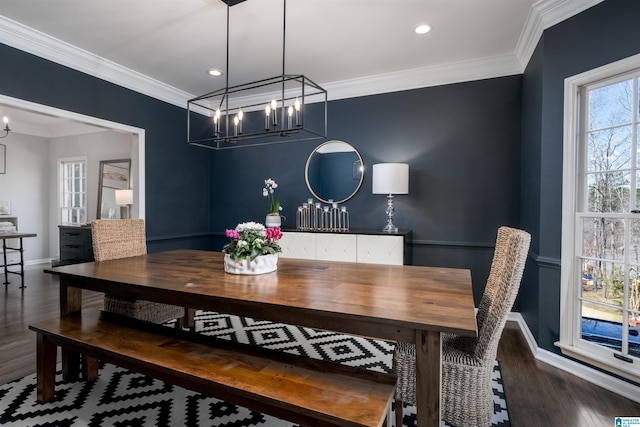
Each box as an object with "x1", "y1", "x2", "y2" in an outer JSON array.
[{"x1": 279, "y1": 230, "x2": 411, "y2": 265}]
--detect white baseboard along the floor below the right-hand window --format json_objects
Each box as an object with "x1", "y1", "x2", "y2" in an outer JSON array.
[{"x1": 508, "y1": 312, "x2": 640, "y2": 403}]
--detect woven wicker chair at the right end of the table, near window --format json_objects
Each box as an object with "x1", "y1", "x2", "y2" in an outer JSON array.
[{"x1": 393, "y1": 227, "x2": 531, "y2": 427}]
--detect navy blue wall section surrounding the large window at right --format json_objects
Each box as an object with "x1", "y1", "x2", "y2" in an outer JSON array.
[{"x1": 520, "y1": 0, "x2": 640, "y2": 352}]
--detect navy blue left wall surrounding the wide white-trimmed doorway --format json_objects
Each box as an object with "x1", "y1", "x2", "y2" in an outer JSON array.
[{"x1": 0, "y1": 44, "x2": 210, "y2": 251}]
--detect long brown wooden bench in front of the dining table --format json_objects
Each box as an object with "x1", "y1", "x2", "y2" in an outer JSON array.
[{"x1": 29, "y1": 310, "x2": 396, "y2": 427}]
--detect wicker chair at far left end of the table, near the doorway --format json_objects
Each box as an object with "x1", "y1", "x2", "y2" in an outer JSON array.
[{"x1": 91, "y1": 219, "x2": 189, "y2": 327}]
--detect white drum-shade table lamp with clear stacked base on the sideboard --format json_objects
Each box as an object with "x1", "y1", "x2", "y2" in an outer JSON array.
[{"x1": 373, "y1": 163, "x2": 409, "y2": 233}]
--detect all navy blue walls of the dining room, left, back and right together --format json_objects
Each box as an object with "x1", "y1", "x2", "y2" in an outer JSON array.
[{"x1": 7, "y1": 0, "x2": 640, "y2": 362}]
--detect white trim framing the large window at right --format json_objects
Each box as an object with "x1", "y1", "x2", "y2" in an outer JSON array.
[{"x1": 555, "y1": 54, "x2": 640, "y2": 382}]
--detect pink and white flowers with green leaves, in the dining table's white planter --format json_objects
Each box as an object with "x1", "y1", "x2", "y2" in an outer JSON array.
[{"x1": 222, "y1": 222, "x2": 282, "y2": 261}]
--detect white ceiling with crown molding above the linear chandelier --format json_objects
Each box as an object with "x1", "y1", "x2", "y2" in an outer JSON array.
[{"x1": 0, "y1": 0, "x2": 602, "y2": 136}]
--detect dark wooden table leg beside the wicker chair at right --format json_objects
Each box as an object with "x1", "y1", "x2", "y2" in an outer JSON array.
[{"x1": 416, "y1": 331, "x2": 442, "y2": 427}]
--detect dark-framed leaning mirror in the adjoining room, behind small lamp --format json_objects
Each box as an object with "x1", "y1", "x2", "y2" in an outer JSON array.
[{"x1": 97, "y1": 159, "x2": 131, "y2": 219}]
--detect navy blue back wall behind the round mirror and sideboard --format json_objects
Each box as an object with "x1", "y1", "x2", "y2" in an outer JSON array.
[{"x1": 211, "y1": 76, "x2": 522, "y2": 304}]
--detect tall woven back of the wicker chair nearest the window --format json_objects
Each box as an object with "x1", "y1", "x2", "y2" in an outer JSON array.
[{"x1": 475, "y1": 227, "x2": 531, "y2": 363}]
